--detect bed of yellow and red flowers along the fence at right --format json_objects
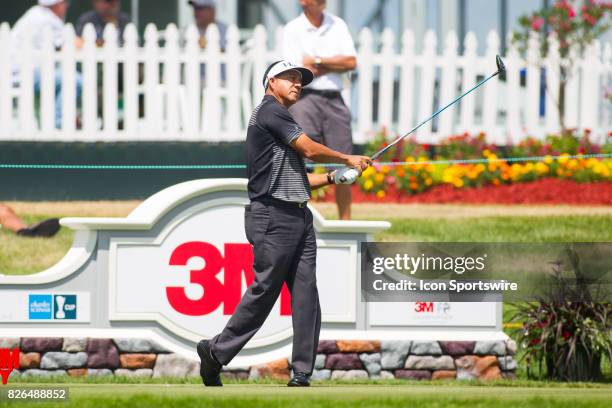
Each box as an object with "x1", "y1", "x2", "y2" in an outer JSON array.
[{"x1": 317, "y1": 130, "x2": 612, "y2": 205}]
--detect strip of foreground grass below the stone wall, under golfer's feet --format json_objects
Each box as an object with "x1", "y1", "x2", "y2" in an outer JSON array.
[{"x1": 0, "y1": 383, "x2": 612, "y2": 408}]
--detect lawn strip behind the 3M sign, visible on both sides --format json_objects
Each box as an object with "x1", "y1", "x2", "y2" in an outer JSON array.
[{"x1": 0, "y1": 201, "x2": 612, "y2": 275}]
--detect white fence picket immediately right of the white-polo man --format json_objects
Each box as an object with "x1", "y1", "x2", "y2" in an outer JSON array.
[{"x1": 354, "y1": 28, "x2": 374, "y2": 143}]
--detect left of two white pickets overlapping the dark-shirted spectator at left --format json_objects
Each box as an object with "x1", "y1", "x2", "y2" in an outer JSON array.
[{"x1": 83, "y1": 23, "x2": 99, "y2": 139}]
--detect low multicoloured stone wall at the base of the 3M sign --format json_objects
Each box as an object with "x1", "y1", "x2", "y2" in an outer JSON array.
[{"x1": 0, "y1": 337, "x2": 517, "y2": 381}]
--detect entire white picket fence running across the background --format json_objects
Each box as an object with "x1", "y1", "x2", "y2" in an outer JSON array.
[{"x1": 0, "y1": 24, "x2": 612, "y2": 144}]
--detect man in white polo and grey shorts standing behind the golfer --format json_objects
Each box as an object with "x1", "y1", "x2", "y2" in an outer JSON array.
[{"x1": 283, "y1": 0, "x2": 357, "y2": 220}]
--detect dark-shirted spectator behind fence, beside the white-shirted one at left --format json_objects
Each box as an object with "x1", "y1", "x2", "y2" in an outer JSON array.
[{"x1": 76, "y1": 0, "x2": 132, "y2": 46}]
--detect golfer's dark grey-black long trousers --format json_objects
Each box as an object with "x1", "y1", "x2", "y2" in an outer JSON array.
[{"x1": 211, "y1": 201, "x2": 321, "y2": 374}]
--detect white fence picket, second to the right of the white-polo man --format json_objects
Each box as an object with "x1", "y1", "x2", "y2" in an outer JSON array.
[{"x1": 378, "y1": 28, "x2": 395, "y2": 128}]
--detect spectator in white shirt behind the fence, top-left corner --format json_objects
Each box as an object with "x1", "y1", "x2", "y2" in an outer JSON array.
[{"x1": 9, "y1": 0, "x2": 82, "y2": 128}]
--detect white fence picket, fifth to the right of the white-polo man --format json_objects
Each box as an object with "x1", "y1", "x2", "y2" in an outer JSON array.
[{"x1": 438, "y1": 31, "x2": 459, "y2": 137}]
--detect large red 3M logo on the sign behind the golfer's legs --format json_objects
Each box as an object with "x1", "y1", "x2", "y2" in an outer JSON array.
[{"x1": 166, "y1": 241, "x2": 291, "y2": 316}]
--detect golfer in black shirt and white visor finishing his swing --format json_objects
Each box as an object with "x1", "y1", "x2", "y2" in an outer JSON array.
[{"x1": 197, "y1": 61, "x2": 371, "y2": 386}]
